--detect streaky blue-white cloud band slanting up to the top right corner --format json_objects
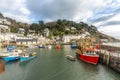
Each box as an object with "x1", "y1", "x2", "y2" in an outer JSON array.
[{"x1": 88, "y1": 0, "x2": 120, "y2": 23}]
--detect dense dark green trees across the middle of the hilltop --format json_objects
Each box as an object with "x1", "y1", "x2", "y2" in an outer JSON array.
[{"x1": 30, "y1": 19, "x2": 96, "y2": 37}]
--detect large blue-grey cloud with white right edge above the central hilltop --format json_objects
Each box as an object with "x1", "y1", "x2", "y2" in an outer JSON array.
[{"x1": 26, "y1": 0, "x2": 104, "y2": 21}]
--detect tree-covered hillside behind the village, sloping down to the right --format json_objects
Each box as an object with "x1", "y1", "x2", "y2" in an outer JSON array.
[{"x1": 0, "y1": 13, "x2": 119, "y2": 41}]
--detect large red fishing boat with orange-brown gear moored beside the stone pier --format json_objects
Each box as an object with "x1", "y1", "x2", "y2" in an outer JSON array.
[{"x1": 76, "y1": 39, "x2": 99, "y2": 65}]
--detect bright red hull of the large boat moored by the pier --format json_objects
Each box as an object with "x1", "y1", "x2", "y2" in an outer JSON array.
[{"x1": 78, "y1": 54, "x2": 99, "y2": 64}]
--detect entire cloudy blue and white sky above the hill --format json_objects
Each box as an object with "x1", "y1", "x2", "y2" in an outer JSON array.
[{"x1": 0, "y1": 0, "x2": 120, "y2": 39}]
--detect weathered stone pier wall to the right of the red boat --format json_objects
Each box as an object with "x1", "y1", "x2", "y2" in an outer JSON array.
[{"x1": 96, "y1": 46, "x2": 120, "y2": 73}]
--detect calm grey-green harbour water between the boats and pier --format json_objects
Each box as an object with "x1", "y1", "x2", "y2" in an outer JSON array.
[{"x1": 0, "y1": 45, "x2": 120, "y2": 80}]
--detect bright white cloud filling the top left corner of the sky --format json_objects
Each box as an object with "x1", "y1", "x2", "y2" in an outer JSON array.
[{"x1": 0, "y1": 0, "x2": 31, "y2": 23}]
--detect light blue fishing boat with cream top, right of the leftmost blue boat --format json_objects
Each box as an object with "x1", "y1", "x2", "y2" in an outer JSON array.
[{"x1": 20, "y1": 52, "x2": 36, "y2": 62}]
